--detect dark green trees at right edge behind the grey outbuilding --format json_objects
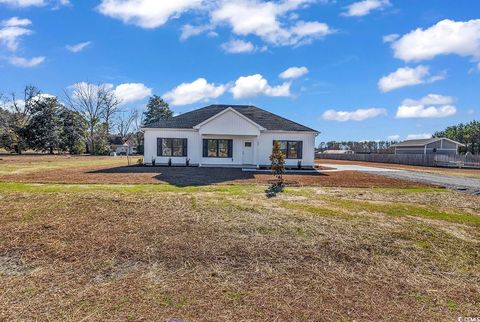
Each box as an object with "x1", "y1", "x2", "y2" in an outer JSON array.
[{"x1": 433, "y1": 121, "x2": 480, "y2": 154}]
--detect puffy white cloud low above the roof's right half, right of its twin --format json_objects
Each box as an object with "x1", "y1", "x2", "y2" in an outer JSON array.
[{"x1": 230, "y1": 74, "x2": 290, "y2": 99}]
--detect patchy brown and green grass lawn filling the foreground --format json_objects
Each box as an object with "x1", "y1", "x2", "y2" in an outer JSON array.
[{"x1": 0, "y1": 157, "x2": 480, "y2": 321}]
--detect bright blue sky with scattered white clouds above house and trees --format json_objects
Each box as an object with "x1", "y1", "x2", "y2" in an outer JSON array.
[{"x1": 0, "y1": 0, "x2": 480, "y2": 141}]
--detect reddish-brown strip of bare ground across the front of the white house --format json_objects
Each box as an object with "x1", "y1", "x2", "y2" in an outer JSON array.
[{"x1": 0, "y1": 166, "x2": 434, "y2": 188}]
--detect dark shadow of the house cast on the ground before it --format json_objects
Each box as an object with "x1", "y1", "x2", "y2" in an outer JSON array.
[{"x1": 88, "y1": 166, "x2": 322, "y2": 187}]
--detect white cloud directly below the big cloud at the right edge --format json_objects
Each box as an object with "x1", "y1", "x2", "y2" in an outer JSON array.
[{"x1": 378, "y1": 65, "x2": 445, "y2": 92}]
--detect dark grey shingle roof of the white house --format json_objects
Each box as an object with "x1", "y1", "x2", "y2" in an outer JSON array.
[{"x1": 144, "y1": 105, "x2": 318, "y2": 132}]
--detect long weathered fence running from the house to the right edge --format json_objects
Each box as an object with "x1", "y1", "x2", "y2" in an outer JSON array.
[{"x1": 316, "y1": 153, "x2": 480, "y2": 169}]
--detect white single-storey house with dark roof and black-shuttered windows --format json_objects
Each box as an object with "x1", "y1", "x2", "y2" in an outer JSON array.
[{"x1": 143, "y1": 105, "x2": 319, "y2": 167}]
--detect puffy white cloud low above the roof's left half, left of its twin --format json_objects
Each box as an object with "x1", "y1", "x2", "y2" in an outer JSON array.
[{"x1": 163, "y1": 78, "x2": 226, "y2": 106}]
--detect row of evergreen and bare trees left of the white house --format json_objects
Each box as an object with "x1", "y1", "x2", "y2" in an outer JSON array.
[{"x1": 0, "y1": 83, "x2": 173, "y2": 155}]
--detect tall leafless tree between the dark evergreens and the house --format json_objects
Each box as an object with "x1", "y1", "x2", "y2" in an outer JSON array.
[{"x1": 64, "y1": 83, "x2": 120, "y2": 153}]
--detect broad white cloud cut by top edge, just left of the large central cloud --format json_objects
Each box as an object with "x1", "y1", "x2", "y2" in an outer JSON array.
[{"x1": 97, "y1": 0, "x2": 202, "y2": 28}]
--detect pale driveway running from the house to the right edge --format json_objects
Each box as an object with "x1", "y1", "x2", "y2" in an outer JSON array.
[{"x1": 321, "y1": 163, "x2": 480, "y2": 195}]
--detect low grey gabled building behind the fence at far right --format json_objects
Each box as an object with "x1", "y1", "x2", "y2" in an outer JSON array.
[{"x1": 392, "y1": 138, "x2": 465, "y2": 154}]
